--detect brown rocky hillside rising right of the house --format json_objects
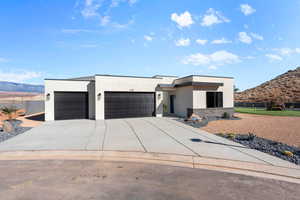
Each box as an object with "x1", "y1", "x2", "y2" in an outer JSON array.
[{"x1": 235, "y1": 67, "x2": 300, "y2": 103}]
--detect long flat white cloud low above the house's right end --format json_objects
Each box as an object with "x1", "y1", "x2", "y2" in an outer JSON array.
[{"x1": 182, "y1": 50, "x2": 240, "y2": 69}]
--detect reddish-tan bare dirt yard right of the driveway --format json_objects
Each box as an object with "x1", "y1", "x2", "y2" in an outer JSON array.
[{"x1": 202, "y1": 113, "x2": 300, "y2": 147}]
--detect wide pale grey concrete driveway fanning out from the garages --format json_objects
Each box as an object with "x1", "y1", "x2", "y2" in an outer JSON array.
[{"x1": 0, "y1": 118, "x2": 296, "y2": 167}]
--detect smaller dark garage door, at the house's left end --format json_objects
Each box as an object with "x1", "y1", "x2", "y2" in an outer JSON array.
[{"x1": 54, "y1": 92, "x2": 88, "y2": 120}]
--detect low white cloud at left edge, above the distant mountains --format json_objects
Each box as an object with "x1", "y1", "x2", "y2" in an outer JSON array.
[{"x1": 0, "y1": 71, "x2": 41, "y2": 83}]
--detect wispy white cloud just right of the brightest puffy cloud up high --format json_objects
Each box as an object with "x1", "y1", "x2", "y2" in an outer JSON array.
[{"x1": 201, "y1": 8, "x2": 230, "y2": 26}]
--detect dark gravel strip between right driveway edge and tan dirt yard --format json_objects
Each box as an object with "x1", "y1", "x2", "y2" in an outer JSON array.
[{"x1": 217, "y1": 133, "x2": 300, "y2": 165}]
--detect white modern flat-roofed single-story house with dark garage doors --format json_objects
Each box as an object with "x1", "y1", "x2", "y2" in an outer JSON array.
[{"x1": 45, "y1": 74, "x2": 234, "y2": 121}]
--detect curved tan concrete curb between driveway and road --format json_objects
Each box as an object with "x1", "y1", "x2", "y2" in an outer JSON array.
[{"x1": 0, "y1": 151, "x2": 300, "y2": 184}]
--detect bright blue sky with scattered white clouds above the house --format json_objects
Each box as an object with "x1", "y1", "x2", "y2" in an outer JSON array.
[{"x1": 0, "y1": 0, "x2": 300, "y2": 89}]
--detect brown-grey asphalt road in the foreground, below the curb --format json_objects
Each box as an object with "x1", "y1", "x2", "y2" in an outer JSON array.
[{"x1": 0, "y1": 161, "x2": 300, "y2": 200}]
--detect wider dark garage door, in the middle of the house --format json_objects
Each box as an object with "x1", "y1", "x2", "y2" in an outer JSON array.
[{"x1": 104, "y1": 92, "x2": 155, "y2": 119}]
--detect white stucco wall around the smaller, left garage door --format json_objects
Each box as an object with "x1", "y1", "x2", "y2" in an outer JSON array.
[{"x1": 45, "y1": 80, "x2": 91, "y2": 121}]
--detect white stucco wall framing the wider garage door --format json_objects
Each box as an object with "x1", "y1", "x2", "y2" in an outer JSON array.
[{"x1": 95, "y1": 76, "x2": 170, "y2": 120}]
